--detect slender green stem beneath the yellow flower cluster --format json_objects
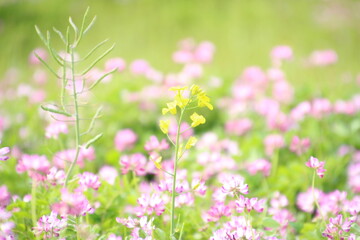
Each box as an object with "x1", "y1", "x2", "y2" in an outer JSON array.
[{"x1": 170, "y1": 109, "x2": 184, "y2": 239}]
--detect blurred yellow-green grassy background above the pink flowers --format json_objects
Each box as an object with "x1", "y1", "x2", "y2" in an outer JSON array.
[{"x1": 0, "y1": 0, "x2": 360, "y2": 98}]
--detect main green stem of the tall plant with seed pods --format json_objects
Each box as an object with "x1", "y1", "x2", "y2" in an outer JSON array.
[{"x1": 64, "y1": 47, "x2": 80, "y2": 187}]
